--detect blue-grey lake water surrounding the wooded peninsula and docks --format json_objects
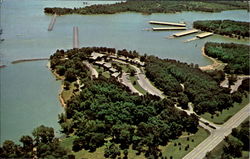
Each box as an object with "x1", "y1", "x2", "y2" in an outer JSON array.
[{"x1": 0, "y1": 0, "x2": 249, "y2": 143}]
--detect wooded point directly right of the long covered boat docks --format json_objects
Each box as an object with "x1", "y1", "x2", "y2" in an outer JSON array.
[{"x1": 193, "y1": 20, "x2": 250, "y2": 39}]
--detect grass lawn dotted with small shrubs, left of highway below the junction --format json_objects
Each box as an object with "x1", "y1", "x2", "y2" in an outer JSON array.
[{"x1": 160, "y1": 127, "x2": 209, "y2": 159}]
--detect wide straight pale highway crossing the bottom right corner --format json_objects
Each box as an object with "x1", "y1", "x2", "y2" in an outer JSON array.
[{"x1": 183, "y1": 103, "x2": 250, "y2": 159}]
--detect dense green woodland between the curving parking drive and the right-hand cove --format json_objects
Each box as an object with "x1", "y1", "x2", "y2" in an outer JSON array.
[{"x1": 145, "y1": 56, "x2": 246, "y2": 114}]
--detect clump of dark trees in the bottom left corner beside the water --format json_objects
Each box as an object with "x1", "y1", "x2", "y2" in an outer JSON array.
[{"x1": 0, "y1": 125, "x2": 75, "y2": 159}]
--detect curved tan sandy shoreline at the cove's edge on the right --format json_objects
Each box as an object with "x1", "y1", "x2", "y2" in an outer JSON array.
[{"x1": 199, "y1": 47, "x2": 225, "y2": 71}]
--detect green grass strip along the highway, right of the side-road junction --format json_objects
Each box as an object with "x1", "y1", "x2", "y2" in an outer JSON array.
[{"x1": 201, "y1": 94, "x2": 250, "y2": 124}]
